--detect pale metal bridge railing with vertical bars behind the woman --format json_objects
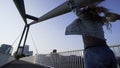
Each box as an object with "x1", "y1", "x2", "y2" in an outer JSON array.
[{"x1": 35, "y1": 45, "x2": 120, "y2": 68}]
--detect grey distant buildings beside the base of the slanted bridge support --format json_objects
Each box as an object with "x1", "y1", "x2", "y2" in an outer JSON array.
[{"x1": 17, "y1": 45, "x2": 33, "y2": 56}]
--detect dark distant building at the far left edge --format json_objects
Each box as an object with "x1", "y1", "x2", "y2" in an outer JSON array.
[{"x1": 0, "y1": 44, "x2": 13, "y2": 55}]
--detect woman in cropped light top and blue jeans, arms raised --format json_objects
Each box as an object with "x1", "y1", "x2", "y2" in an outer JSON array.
[{"x1": 66, "y1": 1, "x2": 120, "y2": 68}]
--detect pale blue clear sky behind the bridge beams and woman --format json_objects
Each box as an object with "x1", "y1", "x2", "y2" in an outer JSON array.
[{"x1": 0, "y1": 0, "x2": 120, "y2": 54}]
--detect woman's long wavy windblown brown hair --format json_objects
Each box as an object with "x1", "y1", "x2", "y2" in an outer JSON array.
[{"x1": 82, "y1": 6, "x2": 111, "y2": 30}]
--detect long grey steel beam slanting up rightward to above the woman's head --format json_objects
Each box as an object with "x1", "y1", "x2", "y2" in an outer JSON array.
[{"x1": 29, "y1": 0, "x2": 104, "y2": 25}]
